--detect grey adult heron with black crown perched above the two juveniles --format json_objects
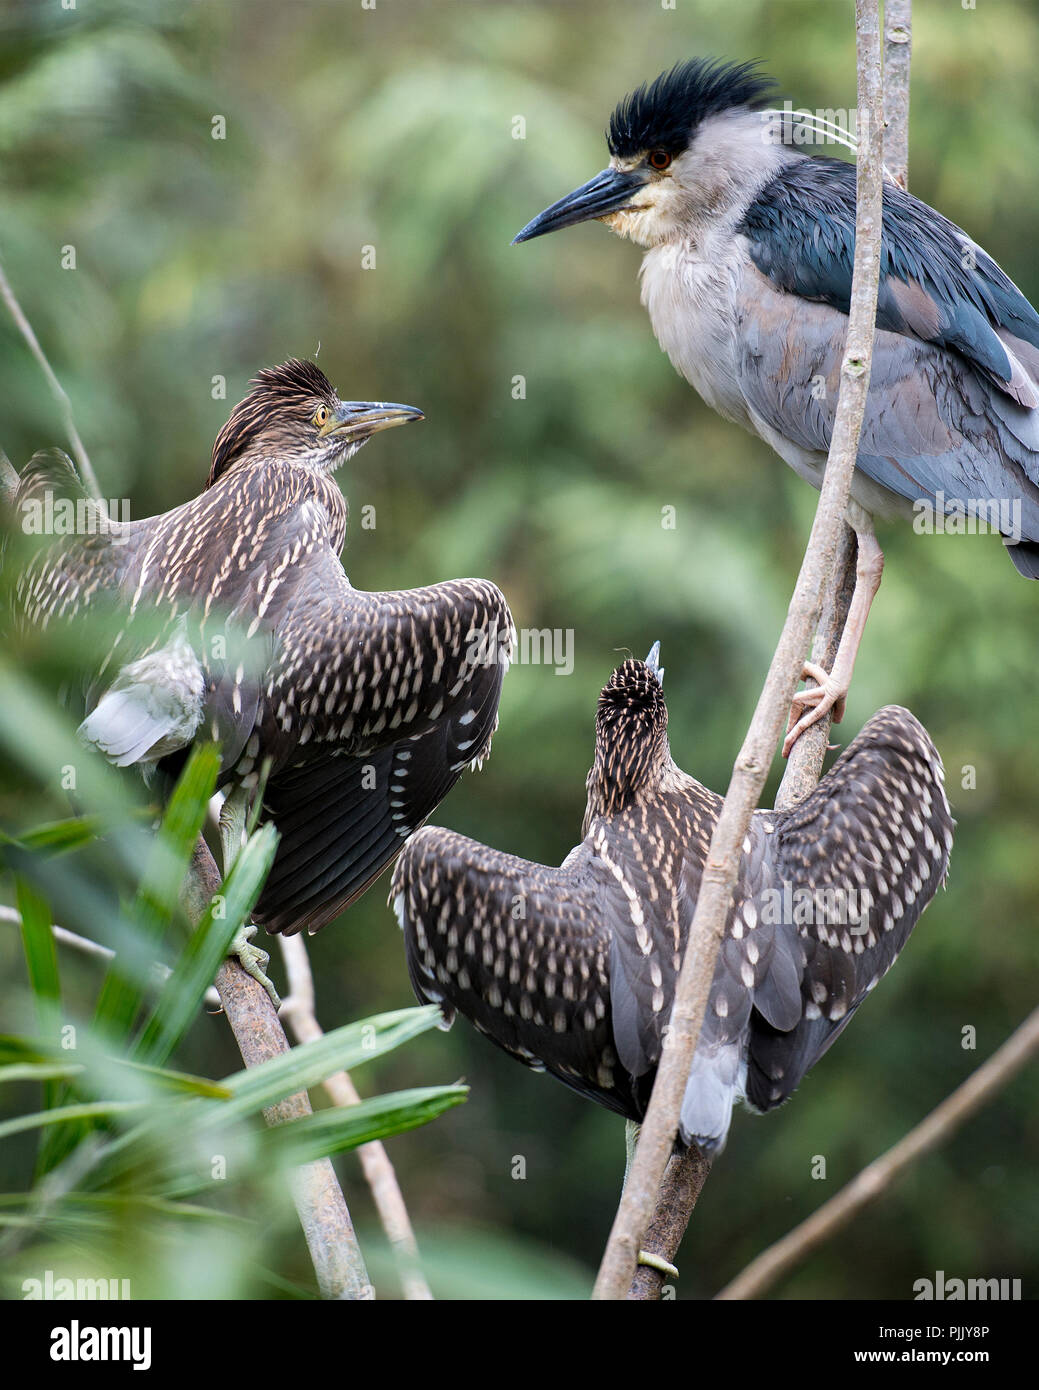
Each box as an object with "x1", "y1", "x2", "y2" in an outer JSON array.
[{"x1": 516, "y1": 60, "x2": 1039, "y2": 752}]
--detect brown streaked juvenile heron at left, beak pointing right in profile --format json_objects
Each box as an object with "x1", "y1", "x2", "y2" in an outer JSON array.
[{"x1": 15, "y1": 360, "x2": 512, "y2": 989}]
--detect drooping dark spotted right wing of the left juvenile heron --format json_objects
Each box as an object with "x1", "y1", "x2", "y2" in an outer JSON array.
[{"x1": 251, "y1": 552, "x2": 512, "y2": 933}]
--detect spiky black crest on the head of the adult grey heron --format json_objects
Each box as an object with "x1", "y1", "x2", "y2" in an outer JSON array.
[{"x1": 606, "y1": 58, "x2": 775, "y2": 158}]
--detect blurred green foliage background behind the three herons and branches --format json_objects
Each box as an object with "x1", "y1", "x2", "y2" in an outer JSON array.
[{"x1": 0, "y1": 0, "x2": 1039, "y2": 1298}]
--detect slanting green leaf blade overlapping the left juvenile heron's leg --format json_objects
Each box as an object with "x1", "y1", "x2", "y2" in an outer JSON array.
[{"x1": 135, "y1": 826, "x2": 278, "y2": 1065}]
